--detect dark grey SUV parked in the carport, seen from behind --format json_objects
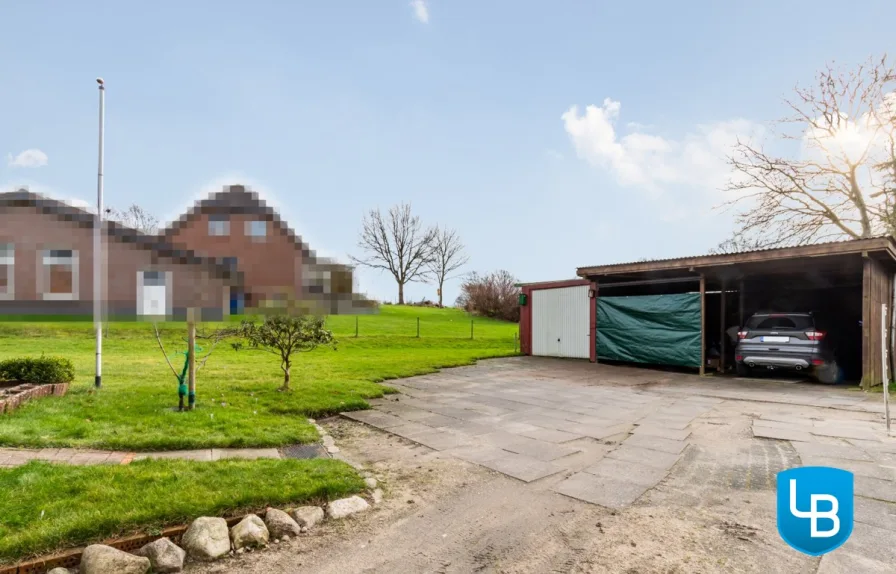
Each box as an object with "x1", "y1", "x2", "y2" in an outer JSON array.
[{"x1": 735, "y1": 313, "x2": 840, "y2": 383}]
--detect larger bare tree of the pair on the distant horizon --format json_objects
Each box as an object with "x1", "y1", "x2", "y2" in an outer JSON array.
[{"x1": 351, "y1": 203, "x2": 435, "y2": 305}]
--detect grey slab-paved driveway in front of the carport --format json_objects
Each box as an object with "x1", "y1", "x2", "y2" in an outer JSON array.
[{"x1": 344, "y1": 358, "x2": 896, "y2": 572}]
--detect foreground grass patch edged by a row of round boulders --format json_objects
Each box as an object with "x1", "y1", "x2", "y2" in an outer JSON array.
[{"x1": 0, "y1": 459, "x2": 364, "y2": 563}]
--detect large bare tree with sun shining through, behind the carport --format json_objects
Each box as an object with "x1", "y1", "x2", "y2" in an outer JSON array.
[{"x1": 727, "y1": 57, "x2": 896, "y2": 247}]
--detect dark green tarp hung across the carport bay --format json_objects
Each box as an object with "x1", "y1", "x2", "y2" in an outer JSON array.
[{"x1": 597, "y1": 293, "x2": 701, "y2": 367}]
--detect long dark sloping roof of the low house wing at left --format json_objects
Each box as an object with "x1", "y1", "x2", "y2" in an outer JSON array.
[{"x1": 0, "y1": 189, "x2": 242, "y2": 284}]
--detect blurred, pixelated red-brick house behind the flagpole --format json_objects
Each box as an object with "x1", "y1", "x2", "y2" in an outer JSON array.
[{"x1": 0, "y1": 186, "x2": 373, "y2": 320}]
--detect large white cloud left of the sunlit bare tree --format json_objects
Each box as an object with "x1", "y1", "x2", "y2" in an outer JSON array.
[{"x1": 561, "y1": 98, "x2": 759, "y2": 197}]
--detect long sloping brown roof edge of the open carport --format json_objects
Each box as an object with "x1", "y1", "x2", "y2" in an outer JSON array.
[{"x1": 576, "y1": 236, "x2": 896, "y2": 277}]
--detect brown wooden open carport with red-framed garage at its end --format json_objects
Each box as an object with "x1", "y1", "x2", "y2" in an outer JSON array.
[{"x1": 520, "y1": 237, "x2": 896, "y2": 388}]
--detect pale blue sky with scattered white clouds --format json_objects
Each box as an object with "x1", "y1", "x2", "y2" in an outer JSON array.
[{"x1": 0, "y1": 0, "x2": 896, "y2": 303}]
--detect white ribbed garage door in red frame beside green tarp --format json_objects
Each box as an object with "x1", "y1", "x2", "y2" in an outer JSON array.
[{"x1": 530, "y1": 285, "x2": 591, "y2": 359}]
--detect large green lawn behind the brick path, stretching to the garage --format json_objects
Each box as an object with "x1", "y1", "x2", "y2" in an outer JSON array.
[{"x1": 0, "y1": 305, "x2": 517, "y2": 451}]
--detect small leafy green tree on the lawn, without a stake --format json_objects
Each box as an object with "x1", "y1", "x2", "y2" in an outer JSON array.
[{"x1": 234, "y1": 315, "x2": 336, "y2": 391}]
